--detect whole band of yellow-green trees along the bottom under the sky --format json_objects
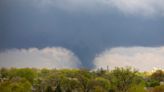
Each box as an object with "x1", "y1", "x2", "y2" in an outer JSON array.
[{"x1": 0, "y1": 67, "x2": 164, "y2": 92}]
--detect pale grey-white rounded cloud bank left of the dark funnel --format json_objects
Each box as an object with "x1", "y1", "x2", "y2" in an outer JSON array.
[{"x1": 0, "y1": 47, "x2": 81, "y2": 69}]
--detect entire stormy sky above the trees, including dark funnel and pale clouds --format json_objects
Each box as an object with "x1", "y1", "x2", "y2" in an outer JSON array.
[{"x1": 0, "y1": 0, "x2": 164, "y2": 70}]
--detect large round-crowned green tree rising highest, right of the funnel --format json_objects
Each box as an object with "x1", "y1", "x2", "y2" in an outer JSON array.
[{"x1": 109, "y1": 67, "x2": 138, "y2": 92}]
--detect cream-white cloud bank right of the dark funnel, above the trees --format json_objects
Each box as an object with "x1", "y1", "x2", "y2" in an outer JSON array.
[{"x1": 93, "y1": 47, "x2": 164, "y2": 71}]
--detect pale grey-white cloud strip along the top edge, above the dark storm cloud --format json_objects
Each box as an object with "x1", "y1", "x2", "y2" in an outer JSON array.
[{"x1": 28, "y1": 0, "x2": 164, "y2": 16}]
